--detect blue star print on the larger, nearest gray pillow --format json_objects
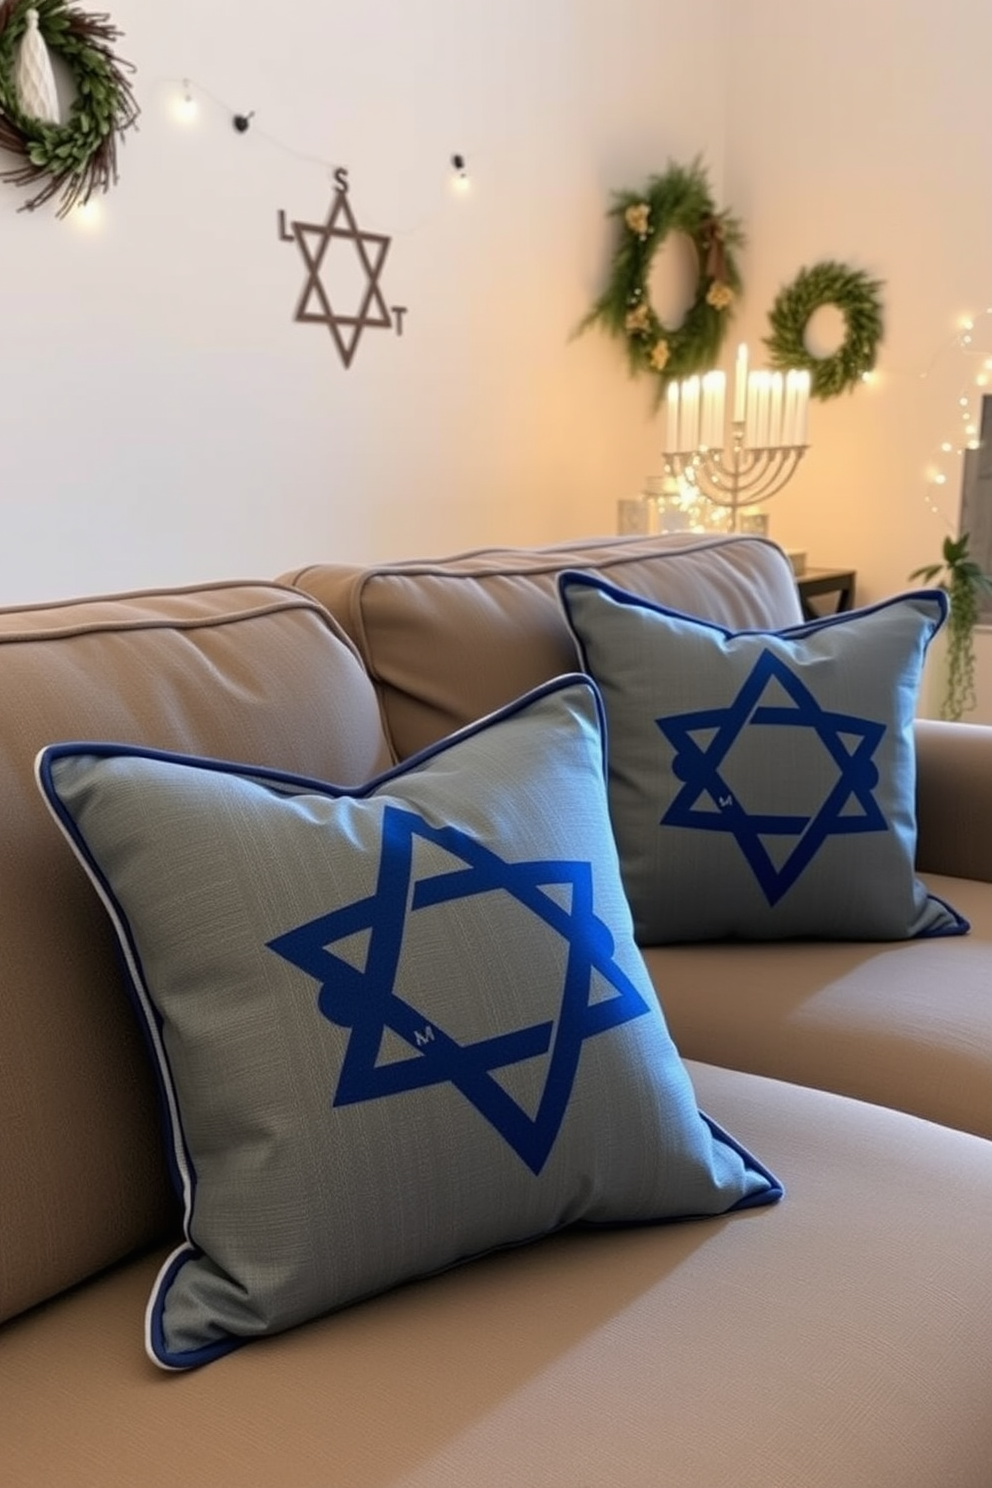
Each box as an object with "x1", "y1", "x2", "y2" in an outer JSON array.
[{"x1": 268, "y1": 805, "x2": 648, "y2": 1174}]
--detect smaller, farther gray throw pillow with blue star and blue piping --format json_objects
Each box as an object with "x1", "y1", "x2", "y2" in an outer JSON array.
[{"x1": 559, "y1": 571, "x2": 968, "y2": 945}]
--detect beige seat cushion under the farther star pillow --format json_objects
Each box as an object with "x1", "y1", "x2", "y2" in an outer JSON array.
[{"x1": 644, "y1": 873, "x2": 992, "y2": 1138}]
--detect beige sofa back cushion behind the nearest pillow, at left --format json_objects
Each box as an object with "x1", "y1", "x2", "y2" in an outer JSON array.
[{"x1": 0, "y1": 583, "x2": 388, "y2": 1321}]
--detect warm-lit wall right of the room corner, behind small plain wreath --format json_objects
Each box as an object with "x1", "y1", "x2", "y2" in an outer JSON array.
[{"x1": 726, "y1": 0, "x2": 992, "y2": 722}]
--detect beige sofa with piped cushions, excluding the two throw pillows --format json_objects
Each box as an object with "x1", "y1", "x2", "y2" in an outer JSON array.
[{"x1": 0, "y1": 539, "x2": 992, "y2": 1488}]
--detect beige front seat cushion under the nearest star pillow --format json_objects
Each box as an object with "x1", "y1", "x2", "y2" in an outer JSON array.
[{"x1": 0, "y1": 1065, "x2": 992, "y2": 1488}]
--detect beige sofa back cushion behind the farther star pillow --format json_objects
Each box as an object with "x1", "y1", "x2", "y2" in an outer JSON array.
[{"x1": 283, "y1": 534, "x2": 802, "y2": 759}]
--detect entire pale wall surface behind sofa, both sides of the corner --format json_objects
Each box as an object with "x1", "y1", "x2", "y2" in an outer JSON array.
[{"x1": 7, "y1": 0, "x2": 992, "y2": 719}]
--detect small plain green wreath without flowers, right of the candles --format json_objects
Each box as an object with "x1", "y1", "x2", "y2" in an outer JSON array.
[{"x1": 764, "y1": 259, "x2": 883, "y2": 399}]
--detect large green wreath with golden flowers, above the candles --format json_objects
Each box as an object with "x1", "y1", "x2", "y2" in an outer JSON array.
[{"x1": 579, "y1": 161, "x2": 744, "y2": 400}]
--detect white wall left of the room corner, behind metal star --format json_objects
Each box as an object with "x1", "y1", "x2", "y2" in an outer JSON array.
[{"x1": 0, "y1": 0, "x2": 726, "y2": 604}]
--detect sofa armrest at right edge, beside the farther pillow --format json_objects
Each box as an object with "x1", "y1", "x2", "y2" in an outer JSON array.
[{"x1": 915, "y1": 719, "x2": 992, "y2": 882}]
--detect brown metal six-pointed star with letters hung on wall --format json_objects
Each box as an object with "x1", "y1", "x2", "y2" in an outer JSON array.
[{"x1": 280, "y1": 170, "x2": 406, "y2": 368}]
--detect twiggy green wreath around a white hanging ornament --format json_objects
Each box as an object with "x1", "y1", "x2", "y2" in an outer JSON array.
[{"x1": 0, "y1": 0, "x2": 138, "y2": 217}]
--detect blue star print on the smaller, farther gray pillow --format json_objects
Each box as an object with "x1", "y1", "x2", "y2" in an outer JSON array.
[{"x1": 656, "y1": 650, "x2": 888, "y2": 908}]
